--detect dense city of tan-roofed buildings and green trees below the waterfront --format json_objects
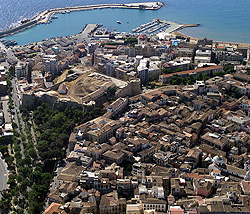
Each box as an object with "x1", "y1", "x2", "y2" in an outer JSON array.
[{"x1": 0, "y1": 20, "x2": 250, "y2": 214}]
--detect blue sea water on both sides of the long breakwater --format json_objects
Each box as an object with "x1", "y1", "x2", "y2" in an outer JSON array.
[{"x1": 0, "y1": 0, "x2": 250, "y2": 45}]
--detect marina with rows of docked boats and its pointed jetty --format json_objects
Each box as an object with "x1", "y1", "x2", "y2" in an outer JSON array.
[{"x1": 132, "y1": 19, "x2": 200, "y2": 34}]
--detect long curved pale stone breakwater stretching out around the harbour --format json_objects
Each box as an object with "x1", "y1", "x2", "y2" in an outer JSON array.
[{"x1": 0, "y1": 2, "x2": 164, "y2": 38}]
